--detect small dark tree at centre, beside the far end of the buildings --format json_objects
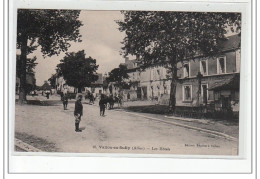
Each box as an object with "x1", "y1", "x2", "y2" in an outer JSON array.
[{"x1": 106, "y1": 64, "x2": 129, "y2": 90}]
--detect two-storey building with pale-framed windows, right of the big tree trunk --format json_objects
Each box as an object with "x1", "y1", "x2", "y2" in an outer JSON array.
[{"x1": 176, "y1": 35, "x2": 241, "y2": 111}]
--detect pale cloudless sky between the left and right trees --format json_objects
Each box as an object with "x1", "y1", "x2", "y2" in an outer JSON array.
[{"x1": 29, "y1": 11, "x2": 125, "y2": 86}]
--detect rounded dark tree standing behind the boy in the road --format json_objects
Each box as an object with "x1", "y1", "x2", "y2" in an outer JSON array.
[{"x1": 56, "y1": 50, "x2": 98, "y2": 92}]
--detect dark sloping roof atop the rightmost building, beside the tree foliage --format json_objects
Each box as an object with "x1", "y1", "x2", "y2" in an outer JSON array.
[{"x1": 220, "y1": 34, "x2": 241, "y2": 51}]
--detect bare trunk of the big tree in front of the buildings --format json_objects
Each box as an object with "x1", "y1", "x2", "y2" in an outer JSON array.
[{"x1": 169, "y1": 68, "x2": 177, "y2": 113}]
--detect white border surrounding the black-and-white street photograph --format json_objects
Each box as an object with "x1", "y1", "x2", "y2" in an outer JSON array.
[{"x1": 9, "y1": 0, "x2": 251, "y2": 173}]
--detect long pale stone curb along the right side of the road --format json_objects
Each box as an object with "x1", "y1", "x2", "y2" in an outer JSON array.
[{"x1": 124, "y1": 111, "x2": 238, "y2": 142}]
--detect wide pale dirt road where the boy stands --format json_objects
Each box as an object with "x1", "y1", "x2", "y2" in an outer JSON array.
[{"x1": 15, "y1": 103, "x2": 238, "y2": 155}]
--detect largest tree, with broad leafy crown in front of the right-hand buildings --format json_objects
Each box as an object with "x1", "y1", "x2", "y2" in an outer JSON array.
[{"x1": 117, "y1": 11, "x2": 241, "y2": 111}]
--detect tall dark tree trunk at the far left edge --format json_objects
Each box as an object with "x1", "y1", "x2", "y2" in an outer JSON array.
[{"x1": 19, "y1": 37, "x2": 27, "y2": 104}]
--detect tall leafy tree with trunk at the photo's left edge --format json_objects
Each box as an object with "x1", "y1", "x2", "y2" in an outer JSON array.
[{"x1": 17, "y1": 9, "x2": 82, "y2": 103}]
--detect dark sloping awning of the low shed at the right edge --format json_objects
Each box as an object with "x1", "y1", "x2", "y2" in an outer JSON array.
[{"x1": 208, "y1": 74, "x2": 240, "y2": 91}]
